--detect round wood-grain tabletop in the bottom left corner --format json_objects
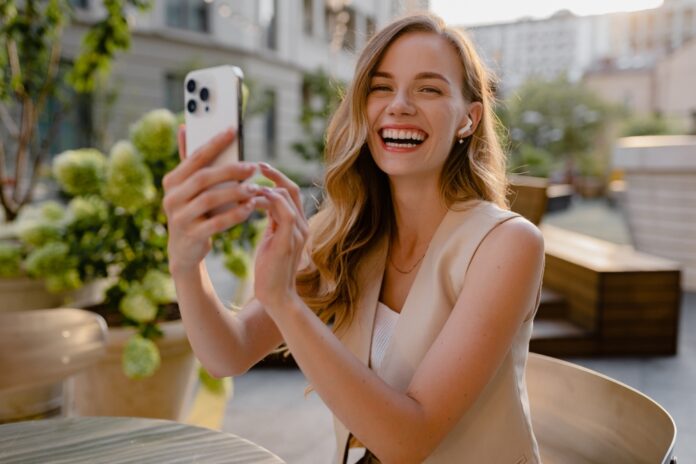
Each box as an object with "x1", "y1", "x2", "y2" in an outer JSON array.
[{"x1": 0, "y1": 417, "x2": 284, "y2": 464}]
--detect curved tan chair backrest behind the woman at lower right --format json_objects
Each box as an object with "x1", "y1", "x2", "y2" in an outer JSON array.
[{"x1": 526, "y1": 353, "x2": 677, "y2": 464}]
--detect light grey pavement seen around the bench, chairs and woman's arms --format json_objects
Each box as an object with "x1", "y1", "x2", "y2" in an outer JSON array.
[{"x1": 208, "y1": 200, "x2": 696, "y2": 464}]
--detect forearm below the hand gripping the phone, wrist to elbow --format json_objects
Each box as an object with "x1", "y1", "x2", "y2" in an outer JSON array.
[{"x1": 172, "y1": 262, "x2": 250, "y2": 377}]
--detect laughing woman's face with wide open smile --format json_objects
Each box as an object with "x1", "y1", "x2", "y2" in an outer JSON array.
[{"x1": 367, "y1": 32, "x2": 470, "y2": 180}]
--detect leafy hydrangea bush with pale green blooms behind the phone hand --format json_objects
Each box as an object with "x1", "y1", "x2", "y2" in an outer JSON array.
[{"x1": 0, "y1": 109, "x2": 262, "y2": 378}]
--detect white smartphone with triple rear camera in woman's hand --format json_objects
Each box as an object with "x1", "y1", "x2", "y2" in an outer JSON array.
[{"x1": 184, "y1": 65, "x2": 244, "y2": 165}]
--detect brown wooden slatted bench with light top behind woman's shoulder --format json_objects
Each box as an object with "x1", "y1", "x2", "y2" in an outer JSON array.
[{"x1": 530, "y1": 225, "x2": 681, "y2": 356}]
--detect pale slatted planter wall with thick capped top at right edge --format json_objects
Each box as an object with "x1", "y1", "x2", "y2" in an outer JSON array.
[{"x1": 614, "y1": 136, "x2": 696, "y2": 291}]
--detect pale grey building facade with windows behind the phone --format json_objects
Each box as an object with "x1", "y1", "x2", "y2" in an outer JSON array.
[{"x1": 63, "y1": 0, "x2": 428, "y2": 174}]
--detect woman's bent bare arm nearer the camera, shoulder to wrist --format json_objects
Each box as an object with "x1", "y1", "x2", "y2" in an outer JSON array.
[{"x1": 257, "y1": 193, "x2": 543, "y2": 463}]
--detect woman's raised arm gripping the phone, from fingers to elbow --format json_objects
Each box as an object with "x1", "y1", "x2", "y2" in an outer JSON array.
[{"x1": 162, "y1": 128, "x2": 282, "y2": 377}]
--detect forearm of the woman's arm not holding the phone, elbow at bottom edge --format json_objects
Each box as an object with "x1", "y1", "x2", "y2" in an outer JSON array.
[{"x1": 272, "y1": 300, "x2": 430, "y2": 463}]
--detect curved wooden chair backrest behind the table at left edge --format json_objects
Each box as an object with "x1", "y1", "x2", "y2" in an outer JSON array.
[{"x1": 0, "y1": 308, "x2": 107, "y2": 423}]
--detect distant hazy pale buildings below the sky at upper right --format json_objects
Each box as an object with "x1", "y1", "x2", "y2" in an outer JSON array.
[{"x1": 465, "y1": 0, "x2": 696, "y2": 95}]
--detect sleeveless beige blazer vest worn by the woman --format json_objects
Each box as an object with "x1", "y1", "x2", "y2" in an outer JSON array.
[{"x1": 334, "y1": 200, "x2": 541, "y2": 464}]
